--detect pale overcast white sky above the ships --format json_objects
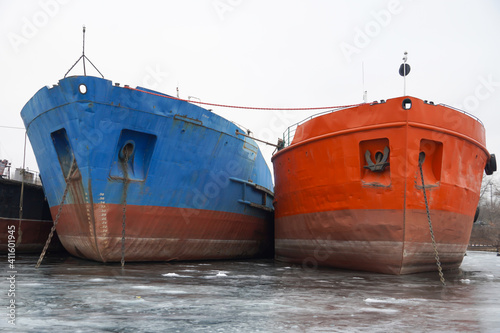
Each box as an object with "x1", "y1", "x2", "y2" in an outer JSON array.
[{"x1": 0, "y1": 0, "x2": 500, "y2": 182}]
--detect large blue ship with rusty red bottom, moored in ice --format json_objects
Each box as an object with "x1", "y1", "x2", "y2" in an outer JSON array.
[{"x1": 21, "y1": 76, "x2": 274, "y2": 263}]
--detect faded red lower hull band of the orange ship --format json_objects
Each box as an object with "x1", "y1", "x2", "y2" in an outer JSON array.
[{"x1": 275, "y1": 210, "x2": 472, "y2": 275}]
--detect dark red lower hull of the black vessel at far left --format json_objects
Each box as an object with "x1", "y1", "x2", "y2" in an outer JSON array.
[{"x1": 0, "y1": 217, "x2": 62, "y2": 253}]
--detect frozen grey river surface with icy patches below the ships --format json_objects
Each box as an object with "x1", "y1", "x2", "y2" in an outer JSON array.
[{"x1": 0, "y1": 252, "x2": 500, "y2": 333}]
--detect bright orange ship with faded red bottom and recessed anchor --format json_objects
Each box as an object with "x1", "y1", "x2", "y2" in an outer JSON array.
[{"x1": 272, "y1": 96, "x2": 496, "y2": 274}]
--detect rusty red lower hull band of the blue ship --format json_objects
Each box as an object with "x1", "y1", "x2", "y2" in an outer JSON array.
[{"x1": 52, "y1": 204, "x2": 273, "y2": 262}]
